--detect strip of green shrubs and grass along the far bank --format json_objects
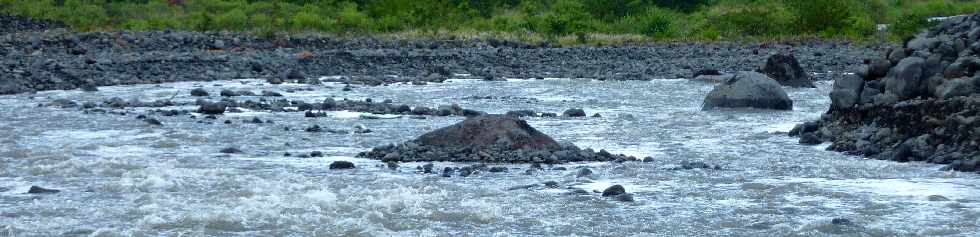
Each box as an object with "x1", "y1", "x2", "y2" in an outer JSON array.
[{"x1": 0, "y1": 0, "x2": 980, "y2": 43}]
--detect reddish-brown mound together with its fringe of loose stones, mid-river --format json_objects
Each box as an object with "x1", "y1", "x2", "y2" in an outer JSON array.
[{"x1": 358, "y1": 115, "x2": 636, "y2": 163}]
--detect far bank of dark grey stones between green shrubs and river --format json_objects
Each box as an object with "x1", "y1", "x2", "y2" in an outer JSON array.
[{"x1": 0, "y1": 26, "x2": 878, "y2": 94}]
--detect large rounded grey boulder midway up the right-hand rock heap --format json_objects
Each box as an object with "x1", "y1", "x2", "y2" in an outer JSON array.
[{"x1": 885, "y1": 57, "x2": 925, "y2": 100}]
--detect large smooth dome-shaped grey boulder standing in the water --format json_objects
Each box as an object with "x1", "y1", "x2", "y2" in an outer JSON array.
[{"x1": 701, "y1": 72, "x2": 793, "y2": 110}]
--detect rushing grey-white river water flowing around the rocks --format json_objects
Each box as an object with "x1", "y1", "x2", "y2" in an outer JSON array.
[{"x1": 0, "y1": 79, "x2": 980, "y2": 236}]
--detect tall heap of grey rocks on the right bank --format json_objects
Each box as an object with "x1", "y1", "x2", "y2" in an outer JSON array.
[{"x1": 791, "y1": 14, "x2": 980, "y2": 172}]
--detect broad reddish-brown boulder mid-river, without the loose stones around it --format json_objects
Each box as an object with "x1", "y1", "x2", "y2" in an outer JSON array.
[{"x1": 415, "y1": 115, "x2": 561, "y2": 150}]
